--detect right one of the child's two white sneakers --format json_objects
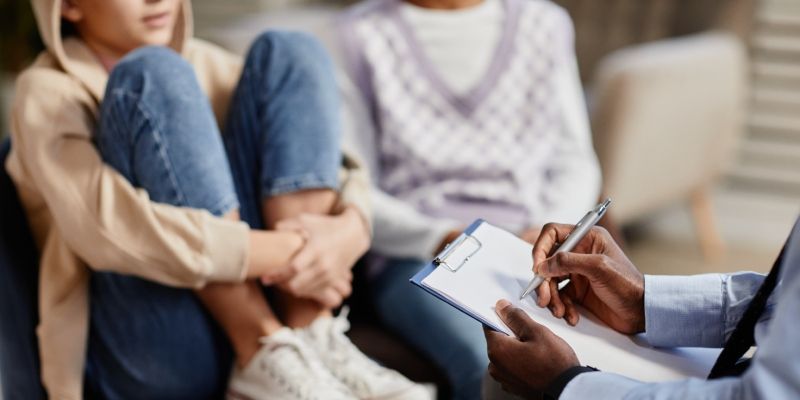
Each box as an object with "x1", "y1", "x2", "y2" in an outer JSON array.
[{"x1": 296, "y1": 307, "x2": 432, "y2": 400}]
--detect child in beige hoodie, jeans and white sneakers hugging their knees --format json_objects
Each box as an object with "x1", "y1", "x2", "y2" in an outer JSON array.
[{"x1": 7, "y1": 0, "x2": 428, "y2": 399}]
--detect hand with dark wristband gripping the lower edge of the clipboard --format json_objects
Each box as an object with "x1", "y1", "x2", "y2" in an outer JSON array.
[{"x1": 483, "y1": 300, "x2": 580, "y2": 398}]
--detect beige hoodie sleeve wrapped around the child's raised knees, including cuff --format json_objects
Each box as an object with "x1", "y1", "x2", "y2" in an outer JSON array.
[{"x1": 13, "y1": 69, "x2": 249, "y2": 288}]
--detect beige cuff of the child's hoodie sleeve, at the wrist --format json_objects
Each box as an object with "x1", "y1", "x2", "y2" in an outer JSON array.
[{"x1": 201, "y1": 214, "x2": 250, "y2": 286}]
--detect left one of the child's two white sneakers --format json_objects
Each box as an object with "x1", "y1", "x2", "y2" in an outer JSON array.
[{"x1": 225, "y1": 328, "x2": 356, "y2": 400}]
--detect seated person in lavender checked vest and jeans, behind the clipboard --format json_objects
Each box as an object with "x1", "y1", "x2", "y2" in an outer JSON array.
[{"x1": 337, "y1": 0, "x2": 600, "y2": 398}]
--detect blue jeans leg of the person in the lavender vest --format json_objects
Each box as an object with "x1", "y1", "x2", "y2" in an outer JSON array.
[{"x1": 370, "y1": 259, "x2": 489, "y2": 399}]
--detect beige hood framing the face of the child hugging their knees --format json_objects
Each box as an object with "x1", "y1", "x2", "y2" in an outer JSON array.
[{"x1": 31, "y1": 0, "x2": 193, "y2": 100}]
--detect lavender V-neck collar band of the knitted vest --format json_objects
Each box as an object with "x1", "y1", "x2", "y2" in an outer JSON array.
[{"x1": 389, "y1": 0, "x2": 519, "y2": 117}]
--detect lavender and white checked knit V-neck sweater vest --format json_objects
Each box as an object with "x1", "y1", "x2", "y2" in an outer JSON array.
[{"x1": 338, "y1": 0, "x2": 573, "y2": 228}]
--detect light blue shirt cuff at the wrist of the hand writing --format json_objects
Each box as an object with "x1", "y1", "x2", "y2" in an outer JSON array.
[{"x1": 644, "y1": 274, "x2": 725, "y2": 347}]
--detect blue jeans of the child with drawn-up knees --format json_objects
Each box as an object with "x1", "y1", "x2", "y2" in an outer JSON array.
[{"x1": 85, "y1": 32, "x2": 341, "y2": 399}]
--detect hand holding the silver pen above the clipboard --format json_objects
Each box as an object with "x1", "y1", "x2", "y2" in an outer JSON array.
[{"x1": 533, "y1": 223, "x2": 645, "y2": 334}]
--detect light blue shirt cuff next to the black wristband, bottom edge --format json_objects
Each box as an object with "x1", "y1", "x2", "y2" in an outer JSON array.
[{"x1": 559, "y1": 371, "x2": 642, "y2": 400}]
